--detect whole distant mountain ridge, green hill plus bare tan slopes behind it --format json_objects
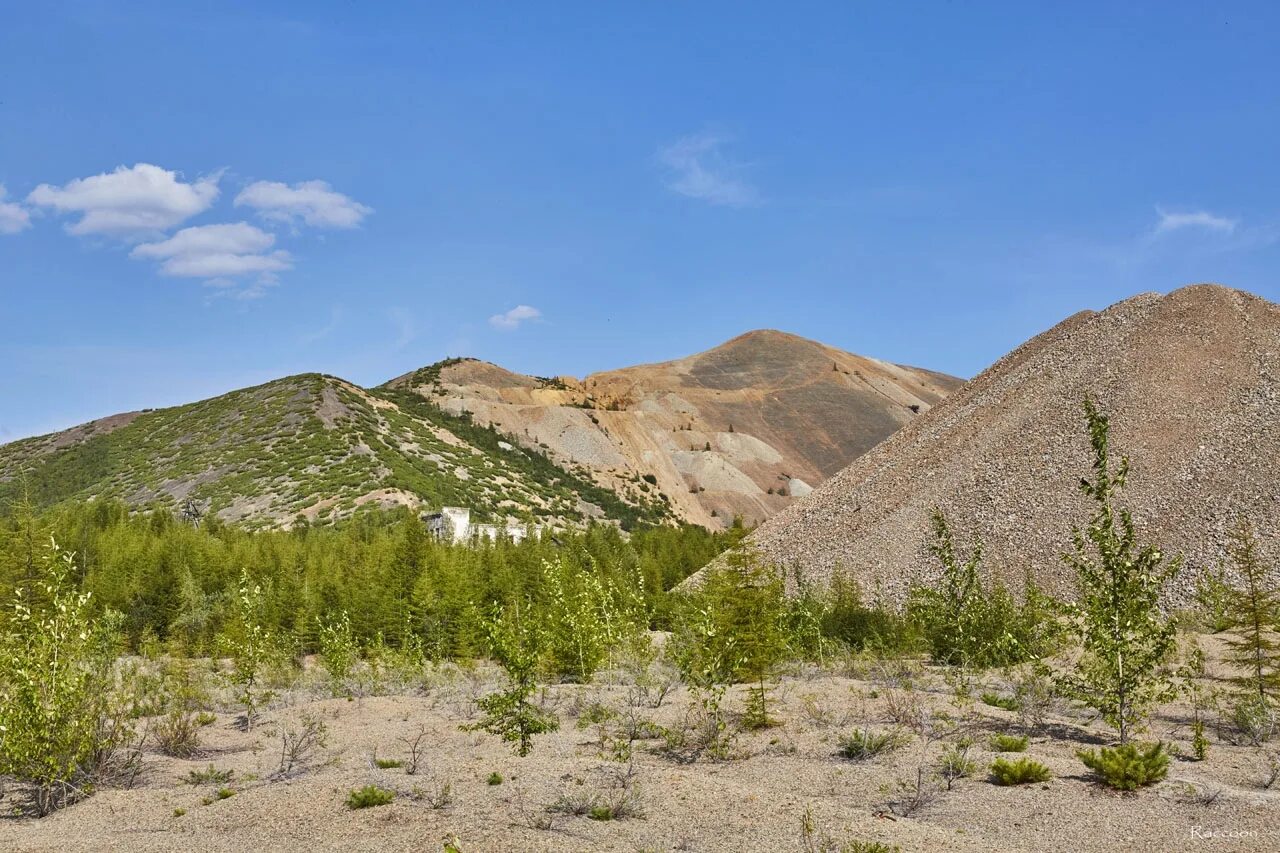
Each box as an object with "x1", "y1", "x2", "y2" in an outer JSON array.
[{"x1": 0, "y1": 332, "x2": 960, "y2": 526}]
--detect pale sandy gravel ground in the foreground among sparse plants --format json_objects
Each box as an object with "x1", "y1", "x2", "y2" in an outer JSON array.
[{"x1": 0, "y1": 648, "x2": 1280, "y2": 853}]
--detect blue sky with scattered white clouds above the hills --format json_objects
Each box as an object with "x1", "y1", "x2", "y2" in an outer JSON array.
[{"x1": 0, "y1": 0, "x2": 1280, "y2": 441}]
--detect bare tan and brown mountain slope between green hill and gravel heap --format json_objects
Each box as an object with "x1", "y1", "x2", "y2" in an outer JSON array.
[{"x1": 388, "y1": 330, "x2": 961, "y2": 526}]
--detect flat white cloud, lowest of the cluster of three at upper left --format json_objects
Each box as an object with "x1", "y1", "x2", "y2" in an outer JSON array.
[{"x1": 129, "y1": 222, "x2": 293, "y2": 279}]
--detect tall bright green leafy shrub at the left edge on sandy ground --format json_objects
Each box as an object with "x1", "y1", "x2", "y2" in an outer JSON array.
[{"x1": 0, "y1": 543, "x2": 132, "y2": 816}]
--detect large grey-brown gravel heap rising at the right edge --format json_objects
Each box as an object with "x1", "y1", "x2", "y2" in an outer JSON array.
[{"x1": 753, "y1": 284, "x2": 1280, "y2": 601}]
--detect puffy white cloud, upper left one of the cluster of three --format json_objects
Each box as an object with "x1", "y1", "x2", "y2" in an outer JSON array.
[{"x1": 27, "y1": 163, "x2": 221, "y2": 238}]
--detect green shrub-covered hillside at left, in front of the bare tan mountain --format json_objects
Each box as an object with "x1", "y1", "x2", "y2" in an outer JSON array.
[{"x1": 0, "y1": 374, "x2": 668, "y2": 528}]
